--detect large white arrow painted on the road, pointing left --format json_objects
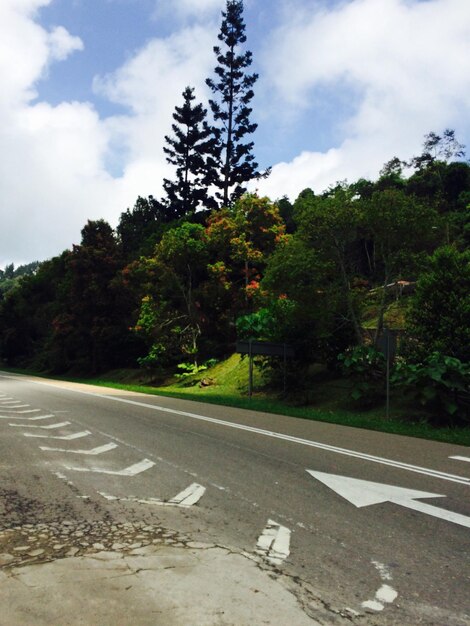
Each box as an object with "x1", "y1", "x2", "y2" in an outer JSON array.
[{"x1": 307, "y1": 470, "x2": 470, "y2": 528}]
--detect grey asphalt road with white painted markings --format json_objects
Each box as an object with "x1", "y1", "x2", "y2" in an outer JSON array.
[{"x1": 0, "y1": 373, "x2": 470, "y2": 626}]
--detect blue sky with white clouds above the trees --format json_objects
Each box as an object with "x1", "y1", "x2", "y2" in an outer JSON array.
[{"x1": 0, "y1": 0, "x2": 470, "y2": 268}]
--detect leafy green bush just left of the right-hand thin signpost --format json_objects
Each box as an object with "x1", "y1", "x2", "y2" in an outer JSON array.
[{"x1": 338, "y1": 346, "x2": 385, "y2": 406}]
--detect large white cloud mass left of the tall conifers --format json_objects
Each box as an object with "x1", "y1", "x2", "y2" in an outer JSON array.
[{"x1": 0, "y1": 0, "x2": 217, "y2": 267}]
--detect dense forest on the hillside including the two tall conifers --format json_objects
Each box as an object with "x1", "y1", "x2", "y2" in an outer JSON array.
[{"x1": 0, "y1": 1, "x2": 470, "y2": 424}]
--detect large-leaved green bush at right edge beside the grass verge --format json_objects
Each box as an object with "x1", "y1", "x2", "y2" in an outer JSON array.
[{"x1": 391, "y1": 352, "x2": 470, "y2": 425}]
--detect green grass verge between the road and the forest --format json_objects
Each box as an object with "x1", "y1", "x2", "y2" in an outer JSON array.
[{"x1": 2, "y1": 355, "x2": 470, "y2": 446}]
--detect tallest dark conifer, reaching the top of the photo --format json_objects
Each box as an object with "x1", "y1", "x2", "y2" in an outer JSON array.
[{"x1": 206, "y1": 0, "x2": 269, "y2": 206}]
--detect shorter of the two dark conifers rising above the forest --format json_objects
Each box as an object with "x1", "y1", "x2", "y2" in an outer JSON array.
[{"x1": 163, "y1": 87, "x2": 217, "y2": 219}]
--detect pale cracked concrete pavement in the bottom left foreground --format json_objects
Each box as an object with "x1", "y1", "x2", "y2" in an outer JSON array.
[{"x1": 0, "y1": 523, "x2": 324, "y2": 626}]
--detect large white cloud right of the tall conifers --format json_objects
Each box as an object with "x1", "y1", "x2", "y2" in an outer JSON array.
[{"x1": 259, "y1": 0, "x2": 470, "y2": 197}]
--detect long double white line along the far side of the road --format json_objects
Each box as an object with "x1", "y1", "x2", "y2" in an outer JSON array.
[{"x1": 15, "y1": 375, "x2": 470, "y2": 485}]
